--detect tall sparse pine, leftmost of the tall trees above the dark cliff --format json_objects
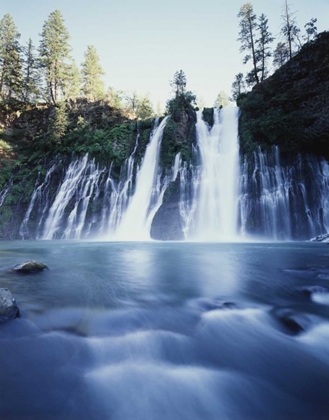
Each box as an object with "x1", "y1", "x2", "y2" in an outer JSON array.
[{"x1": 238, "y1": 3, "x2": 259, "y2": 84}]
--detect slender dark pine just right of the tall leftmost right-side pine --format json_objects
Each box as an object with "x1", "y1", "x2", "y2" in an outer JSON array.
[{"x1": 255, "y1": 13, "x2": 274, "y2": 81}]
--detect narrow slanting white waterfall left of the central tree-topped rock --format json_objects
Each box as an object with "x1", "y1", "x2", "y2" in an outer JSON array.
[{"x1": 113, "y1": 117, "x2": 168, "y2": 240}]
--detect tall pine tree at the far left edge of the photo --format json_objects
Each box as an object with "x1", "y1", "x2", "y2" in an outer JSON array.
[{"x1": 0, "y1": 14, "x2": 23, "y2": 99}]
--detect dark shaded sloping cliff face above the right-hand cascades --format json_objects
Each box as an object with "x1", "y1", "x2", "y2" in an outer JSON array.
[{"x1": 238, "y1": 32, "x2": 329, "y2": 158}]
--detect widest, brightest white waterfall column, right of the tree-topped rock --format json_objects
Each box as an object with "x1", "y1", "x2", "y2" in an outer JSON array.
[{"x1": 193, "y1": 107, "x2": 239, "y2": 241}]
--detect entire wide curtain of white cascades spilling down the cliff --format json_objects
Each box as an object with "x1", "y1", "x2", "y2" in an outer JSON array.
[{"x1": 16, "y1": 108, "x2": 329, "y2": 241}]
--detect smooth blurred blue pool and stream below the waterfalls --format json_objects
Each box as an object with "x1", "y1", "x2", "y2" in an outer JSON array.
[{"x1": 0, "y1": 241, "x2": 329, "y2": 420}]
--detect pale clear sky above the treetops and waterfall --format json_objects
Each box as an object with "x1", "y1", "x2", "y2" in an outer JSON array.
[{"x1": 0, "y1": 0, "x2": 329, "y2": 108}]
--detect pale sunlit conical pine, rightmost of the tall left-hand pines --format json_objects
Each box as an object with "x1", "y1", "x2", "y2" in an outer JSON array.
[{"x1": 81, "y1": 45, "x2": 105, "y2": 101}]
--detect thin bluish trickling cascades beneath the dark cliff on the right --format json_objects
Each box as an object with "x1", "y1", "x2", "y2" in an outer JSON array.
[{"x1": 239, "y1": 146, "x2": 329, "y2": 240}]
